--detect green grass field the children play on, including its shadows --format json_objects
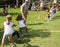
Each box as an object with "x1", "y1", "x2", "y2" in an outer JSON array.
[{"x1": 0, "y1": 8, "x2": 60, "y2": 47}]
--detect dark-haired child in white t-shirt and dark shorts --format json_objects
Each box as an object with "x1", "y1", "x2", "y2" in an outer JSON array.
[{"x1": 16, "y1": 14, "x2": 28, "y2": 35}]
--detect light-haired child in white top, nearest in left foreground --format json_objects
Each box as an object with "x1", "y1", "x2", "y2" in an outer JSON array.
[{"x1": 2, "y1": 15, "x2": 16, "y2": 47}]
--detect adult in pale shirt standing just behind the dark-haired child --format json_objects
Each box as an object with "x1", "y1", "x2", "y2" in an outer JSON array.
[{"x1": 21, "y1": 0, "x2": 28, "y2": 24}]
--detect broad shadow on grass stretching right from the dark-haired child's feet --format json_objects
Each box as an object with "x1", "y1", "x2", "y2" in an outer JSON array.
[{"x1": 29, "y1": 29, "x2": 51, "y2": 38}]
